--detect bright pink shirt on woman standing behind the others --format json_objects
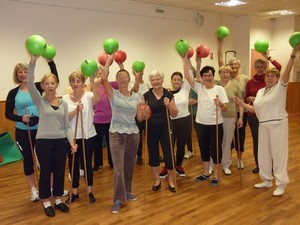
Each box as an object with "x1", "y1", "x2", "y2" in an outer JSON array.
[{"x1": 93, "y1": 81, "x2": 119, "y2": 123}]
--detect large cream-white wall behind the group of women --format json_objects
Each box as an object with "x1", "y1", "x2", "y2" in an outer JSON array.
[{"x1": 0, "y1": 0, "x2": 298, "y2": 100}]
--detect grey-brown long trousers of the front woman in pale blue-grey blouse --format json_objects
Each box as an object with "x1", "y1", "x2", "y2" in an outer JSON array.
[{"x1": 109, "y1": 132, "x2": 140, "y2": 203}]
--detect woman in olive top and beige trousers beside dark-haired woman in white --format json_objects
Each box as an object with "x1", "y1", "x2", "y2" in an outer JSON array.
[{"x1": 216, "y1": 66, "x2": 243, "y2": 175}]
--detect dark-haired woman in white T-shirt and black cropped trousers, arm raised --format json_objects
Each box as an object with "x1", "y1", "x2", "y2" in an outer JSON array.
[{"x1": 183, "y1": 57, "x2": 228, "y2": 186}]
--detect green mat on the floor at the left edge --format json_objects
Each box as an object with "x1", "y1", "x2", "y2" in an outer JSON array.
[{"x1": 0, "y1": 132, "x2": 23, "y2": 166}]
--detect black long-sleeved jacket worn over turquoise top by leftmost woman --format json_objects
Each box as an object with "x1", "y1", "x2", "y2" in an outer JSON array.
[{"x1": 5, "y1": 61, "x2": 59, "y2": 122}]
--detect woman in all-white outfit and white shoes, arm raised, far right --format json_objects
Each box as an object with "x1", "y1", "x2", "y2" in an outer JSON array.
[{"x1": 235, "y1": 45, "x2": 300, "y2": 196}]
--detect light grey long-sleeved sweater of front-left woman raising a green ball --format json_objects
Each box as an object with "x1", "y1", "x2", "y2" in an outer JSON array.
[{"x1": 27, "y1": 63, "x2": 73, "y2": 143}]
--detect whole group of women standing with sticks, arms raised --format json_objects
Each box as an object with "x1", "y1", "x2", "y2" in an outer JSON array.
[{"x1": 6, "y1": 40, "x2": 300, "y2": 217}]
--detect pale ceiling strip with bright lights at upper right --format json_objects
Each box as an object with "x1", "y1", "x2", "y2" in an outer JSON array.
[{"x1": 130, "y1": 0, "x2": 300, "y2": 18}]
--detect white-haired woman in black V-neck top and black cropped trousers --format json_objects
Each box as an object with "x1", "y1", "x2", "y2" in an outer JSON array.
[{"x1": 143, "y1": 70, "x2": 178, "y2": 192}]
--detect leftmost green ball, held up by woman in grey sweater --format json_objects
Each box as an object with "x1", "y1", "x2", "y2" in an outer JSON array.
[{"x1": 25, "y1": 35, "x2": 46, "y2": 56}]
